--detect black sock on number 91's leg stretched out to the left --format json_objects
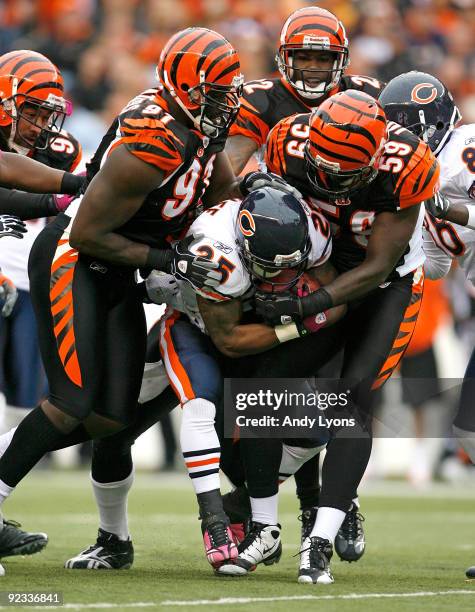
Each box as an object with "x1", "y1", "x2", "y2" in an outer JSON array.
[{"x1": 0, "y1": 406, "x2": 90, "y2": 487}]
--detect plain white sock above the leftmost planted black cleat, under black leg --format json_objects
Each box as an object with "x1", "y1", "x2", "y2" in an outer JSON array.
[{"x1": 91, "y1": 469, "x2": 134, "y2": 540}]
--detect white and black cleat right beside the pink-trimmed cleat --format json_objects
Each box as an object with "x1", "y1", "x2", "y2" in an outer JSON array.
[{"x1": 216, "y1": 523, "x2": 282, "y2": 576}]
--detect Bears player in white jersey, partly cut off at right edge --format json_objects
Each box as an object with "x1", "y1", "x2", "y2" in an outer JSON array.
[{"x1": 380, "y1": 70, "x2": 475, "y2": 578}]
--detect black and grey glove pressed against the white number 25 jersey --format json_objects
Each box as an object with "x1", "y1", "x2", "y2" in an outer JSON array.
[{"x1": 165, "y1": 235, "x2": 222, "y2": 289}]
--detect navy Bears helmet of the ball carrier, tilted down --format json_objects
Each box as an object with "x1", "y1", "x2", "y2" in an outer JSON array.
[{"x1": 236, "y1": 187, "x2": 312, "y2": 287}]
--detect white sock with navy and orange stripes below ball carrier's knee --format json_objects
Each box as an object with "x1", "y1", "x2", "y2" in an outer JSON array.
[{"x1": 180, "y1": 398, "x2": 221, "y2": 494}]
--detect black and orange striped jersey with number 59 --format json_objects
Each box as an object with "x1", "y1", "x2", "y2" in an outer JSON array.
[{"x1": 265, "y1": 113, "x2": 439, "y2": 280}]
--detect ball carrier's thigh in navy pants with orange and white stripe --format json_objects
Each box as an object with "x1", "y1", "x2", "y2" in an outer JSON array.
[{"x1": 160, "y1": 311, "x2": 223, "y2": 404}]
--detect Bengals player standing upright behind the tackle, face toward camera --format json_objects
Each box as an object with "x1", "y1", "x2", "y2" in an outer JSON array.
[{"x1": 226, "y1": 6, "x2": 382, "y2": 561}]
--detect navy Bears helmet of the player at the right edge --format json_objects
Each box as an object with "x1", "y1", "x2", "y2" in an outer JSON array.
[{"x1": 379, "y1": 70, "x2": 461, "y2": 155}]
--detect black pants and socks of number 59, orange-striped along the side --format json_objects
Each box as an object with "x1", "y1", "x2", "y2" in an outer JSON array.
[{"x1": 240, "y1": 269, "x2": 423, "y2": 512}]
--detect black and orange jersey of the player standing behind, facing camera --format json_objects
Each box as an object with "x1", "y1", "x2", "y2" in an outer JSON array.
[{"x1": 229, "y1": 75, "x2": 384, "y2": 147}]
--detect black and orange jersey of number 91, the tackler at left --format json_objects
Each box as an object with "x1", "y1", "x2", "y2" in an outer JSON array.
[{"x1": 87, "y1": 88, "x2": 225, "y2": 248}]
